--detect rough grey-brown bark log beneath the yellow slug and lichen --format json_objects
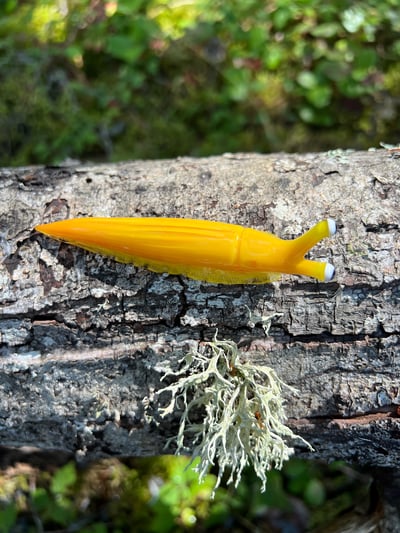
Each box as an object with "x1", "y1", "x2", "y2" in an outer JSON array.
[{"x1": 0, "y1": 150, "x2": 400, "y2": 467}]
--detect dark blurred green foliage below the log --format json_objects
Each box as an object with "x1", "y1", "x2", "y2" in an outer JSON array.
[{"x1": 0, "y1": 456, "x2": 371, "y2": 533}]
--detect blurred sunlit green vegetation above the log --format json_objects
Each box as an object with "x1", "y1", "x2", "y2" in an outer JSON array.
[{"x1": 0, "y1": 0, "x2": 400, "y2": 165}]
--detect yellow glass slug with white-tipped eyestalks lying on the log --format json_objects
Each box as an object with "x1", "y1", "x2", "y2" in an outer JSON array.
[{"x1": 36, "y1": 218, "x2": 336, "y2": 284}]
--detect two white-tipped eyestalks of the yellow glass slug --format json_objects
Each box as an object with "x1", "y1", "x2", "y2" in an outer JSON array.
[{"x1": 292, "y1": 218, "x2": 336, "y2": 281}]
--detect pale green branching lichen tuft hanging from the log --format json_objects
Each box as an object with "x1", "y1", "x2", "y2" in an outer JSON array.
[{"x1": 158, "y1": 336, "x2": 311, "y2": 491}]
